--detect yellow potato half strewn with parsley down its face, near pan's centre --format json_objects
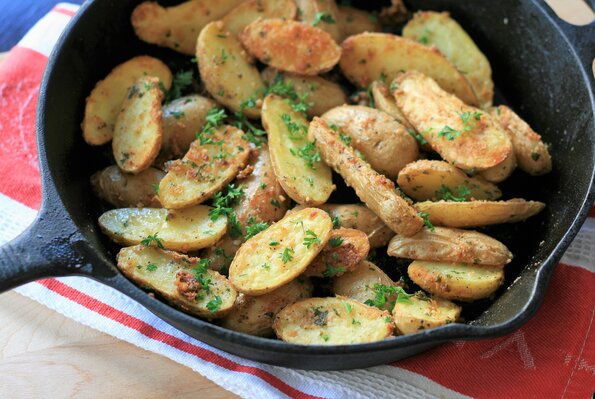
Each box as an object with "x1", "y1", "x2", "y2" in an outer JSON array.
[{"x1": 262, "y1": 94, "x2": 335, "y2": 205}]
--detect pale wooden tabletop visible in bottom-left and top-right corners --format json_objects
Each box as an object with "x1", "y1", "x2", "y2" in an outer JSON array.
[{"x1": 0, "y1": 0, "x2": 595, "y2": 399}]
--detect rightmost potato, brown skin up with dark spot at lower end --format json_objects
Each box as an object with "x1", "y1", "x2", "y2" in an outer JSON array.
[{"x1": 490, "y1": 105, "x2": 552, "y2": 176}]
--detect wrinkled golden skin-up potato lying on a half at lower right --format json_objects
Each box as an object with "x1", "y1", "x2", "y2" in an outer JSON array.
[{"x1": 387, "y1": 227, "x2": 512, "y2": 267}]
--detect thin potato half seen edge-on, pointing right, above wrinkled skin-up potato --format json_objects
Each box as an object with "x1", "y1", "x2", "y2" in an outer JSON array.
[{"x1": 414, "y1": 198, "x2": 545, "y2": 227}]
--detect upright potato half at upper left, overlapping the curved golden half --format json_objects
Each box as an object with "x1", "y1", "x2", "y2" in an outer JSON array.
[{"x1": 112, "y1": 76, "x2": 163, "y2": 174}]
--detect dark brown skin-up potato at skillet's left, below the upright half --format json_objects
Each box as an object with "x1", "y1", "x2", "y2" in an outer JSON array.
[{"x1": 91, "y1": 165, "x2": 165, "y2": 208}]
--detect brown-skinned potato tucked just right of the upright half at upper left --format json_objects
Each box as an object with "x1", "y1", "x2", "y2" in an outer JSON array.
[{"x1": 155, "y1": 94, "x2": 217, "y2": 165}]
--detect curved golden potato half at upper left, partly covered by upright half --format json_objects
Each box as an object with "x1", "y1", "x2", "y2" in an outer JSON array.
[{"x1": 82, "y1": 56, "x2": 172, "y2": 145}]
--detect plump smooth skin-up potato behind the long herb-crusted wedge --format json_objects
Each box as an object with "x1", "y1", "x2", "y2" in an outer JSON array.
[{"x1": 322, "y1": 105, "x2": 419, "y2": 179}]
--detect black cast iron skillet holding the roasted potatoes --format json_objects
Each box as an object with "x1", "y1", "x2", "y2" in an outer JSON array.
[{"x1": 0, "y1": 0, "x2": 595, "y2": 370}]
